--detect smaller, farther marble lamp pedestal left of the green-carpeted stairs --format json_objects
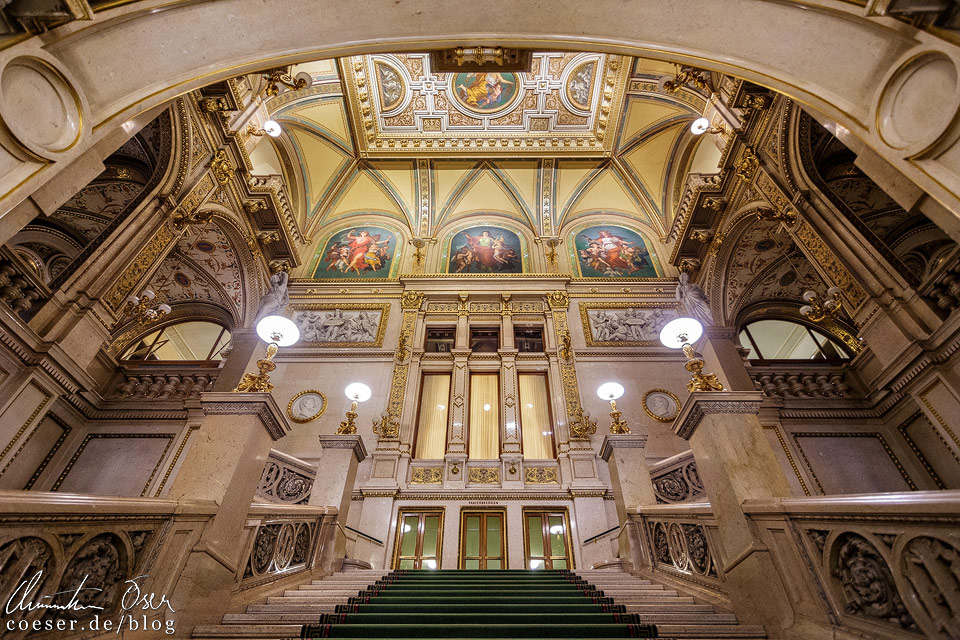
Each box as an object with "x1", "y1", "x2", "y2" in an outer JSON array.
[{"x1": 309, "y1": 434, "x2": 367, "y2": 571}]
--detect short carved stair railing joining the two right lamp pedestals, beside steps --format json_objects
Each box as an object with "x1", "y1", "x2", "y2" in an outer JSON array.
[{"x1": 629, "y1": 502, "x2": 724, "y2": 597}]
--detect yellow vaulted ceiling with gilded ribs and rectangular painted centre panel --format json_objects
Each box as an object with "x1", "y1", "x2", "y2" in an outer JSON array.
[{"x1": 251, "y1": 52, "x2": 720, "y2": 275}]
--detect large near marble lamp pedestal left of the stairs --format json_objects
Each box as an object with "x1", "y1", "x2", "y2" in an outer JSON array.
[{"x1": 166, "y1": 392, "x2": 290, "y2": 627}]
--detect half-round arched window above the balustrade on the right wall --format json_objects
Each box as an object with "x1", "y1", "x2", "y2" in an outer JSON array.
[{"x1": 740, "y1": 320, "x2": 850, "y2": 360}]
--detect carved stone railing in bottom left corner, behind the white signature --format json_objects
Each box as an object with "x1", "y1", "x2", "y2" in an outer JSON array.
[{"x1": 0, "y1": 491, "x2": 217, "y2": 640}]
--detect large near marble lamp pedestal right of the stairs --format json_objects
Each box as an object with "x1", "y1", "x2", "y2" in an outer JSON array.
[{"x1": 674, "y1": 391, "x2": 795, "y2": 637}]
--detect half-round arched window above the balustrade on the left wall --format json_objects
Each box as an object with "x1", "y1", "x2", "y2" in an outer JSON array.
[{"x1": 121, "y1": 320, "x2": 230, "y2": 361}]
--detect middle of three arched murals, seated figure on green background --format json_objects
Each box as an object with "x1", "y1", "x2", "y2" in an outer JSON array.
[{"x1": 446, "y1": 225, "x2": 523, "y2": 273}]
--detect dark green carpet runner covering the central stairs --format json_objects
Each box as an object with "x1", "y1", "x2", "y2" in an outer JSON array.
[{"x1": 300, "y1": 570, "x2": 657, "y2": 639}]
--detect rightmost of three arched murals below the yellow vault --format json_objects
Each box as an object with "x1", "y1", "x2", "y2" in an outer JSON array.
[{"x1": 572, "y1": 225, "x2": 661, "y2": 278}]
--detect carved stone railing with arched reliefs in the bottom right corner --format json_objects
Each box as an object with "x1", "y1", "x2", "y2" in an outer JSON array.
[{"x1": 743, "y1": 491, "x2": 960, "y2": 640}]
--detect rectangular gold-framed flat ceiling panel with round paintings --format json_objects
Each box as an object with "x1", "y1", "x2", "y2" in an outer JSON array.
[{"x1": 341, "y1": 49, "x2": 631, "y2": 158}]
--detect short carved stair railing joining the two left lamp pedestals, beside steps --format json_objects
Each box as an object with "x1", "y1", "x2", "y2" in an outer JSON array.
[{"x1": 238, "y1": 504, "x2": 337, "y2": 589}]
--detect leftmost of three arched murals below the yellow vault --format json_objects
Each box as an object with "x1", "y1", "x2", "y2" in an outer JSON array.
[{"x1": 313, "y1": 225, "x2": 399, "y2": 280}]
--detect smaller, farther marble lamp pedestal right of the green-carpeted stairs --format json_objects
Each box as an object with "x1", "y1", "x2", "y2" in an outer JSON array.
[{"x1": 600, "y1": 433, "x2": 657, "y2": 571}]
